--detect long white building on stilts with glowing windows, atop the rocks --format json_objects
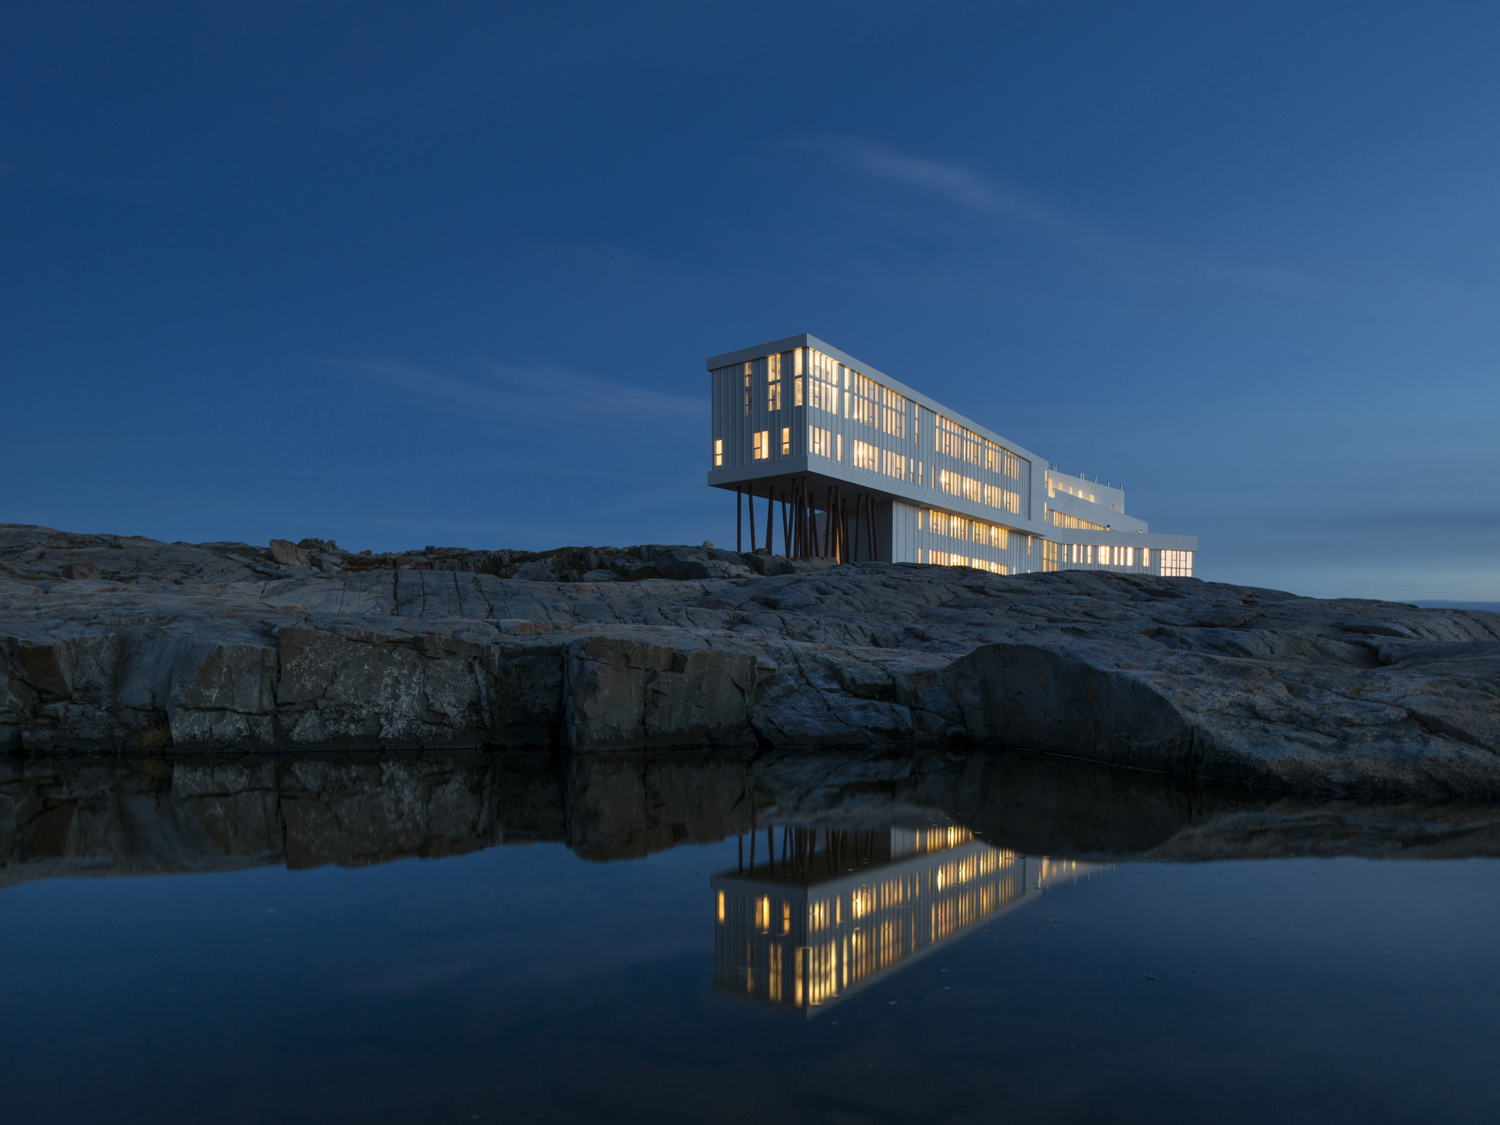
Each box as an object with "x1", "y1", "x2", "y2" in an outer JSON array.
[{"x1": 708, "y1": 335, "x2": 1199, "y2": 578}]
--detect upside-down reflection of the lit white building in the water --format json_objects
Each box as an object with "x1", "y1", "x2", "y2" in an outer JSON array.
[{"x1": 710, "y1": 825, "x2": 1098, "y2": 1016}]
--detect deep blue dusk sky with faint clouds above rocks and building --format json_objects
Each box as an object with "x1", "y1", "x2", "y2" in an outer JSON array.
[{"x1": 0, "y1": 0, "x2": 1500, "y2": 600}]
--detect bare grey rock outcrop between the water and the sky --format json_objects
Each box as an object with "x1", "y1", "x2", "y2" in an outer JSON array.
[{"x1": 0, "y1": 525, "x2": 1500, "y2": 800}]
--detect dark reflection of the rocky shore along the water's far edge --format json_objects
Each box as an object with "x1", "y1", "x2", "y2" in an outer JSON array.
[{"x1": 0, "y1": 752, "x2": 1500, "y2": 882}]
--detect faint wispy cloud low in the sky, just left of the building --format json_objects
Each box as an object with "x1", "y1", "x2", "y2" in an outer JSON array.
[{"x1": 330, "y1": 360, "x2": 708, "y2": 423}]
